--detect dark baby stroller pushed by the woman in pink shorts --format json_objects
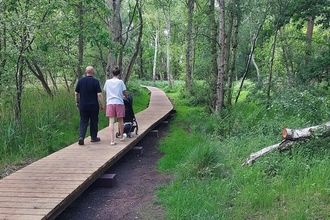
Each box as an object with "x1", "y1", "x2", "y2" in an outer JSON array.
[{"x1": 116, "y1": 95, "x2": 138, "y2": 138}]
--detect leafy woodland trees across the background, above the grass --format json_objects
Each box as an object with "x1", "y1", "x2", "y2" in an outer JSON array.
[{"x1": 0, "y1": 0, "x2": 330, "y2": 119}]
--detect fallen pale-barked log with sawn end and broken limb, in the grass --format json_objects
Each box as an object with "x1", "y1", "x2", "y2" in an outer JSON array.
[{"x1": 242, "y1": 122, "x2": 330, "y2": 167}]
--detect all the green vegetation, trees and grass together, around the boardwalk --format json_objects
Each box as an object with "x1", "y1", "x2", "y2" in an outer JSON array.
[{"x1": 0, "y1": 0, "x2": 330, "y2": 220}]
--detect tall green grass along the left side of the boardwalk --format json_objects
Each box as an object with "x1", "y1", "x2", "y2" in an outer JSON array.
[{"x1": 0, "y1": 82, "x2": 149, "y2": 177}]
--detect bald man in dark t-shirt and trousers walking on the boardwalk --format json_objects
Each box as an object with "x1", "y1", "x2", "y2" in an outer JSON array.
[{"x1": 75, "y1": 66, "x2": 104, "y2": 145}]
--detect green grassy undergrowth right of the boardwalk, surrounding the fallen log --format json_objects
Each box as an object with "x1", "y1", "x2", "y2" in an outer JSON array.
[{"x1": 158, "y1": 82, "x2": 330, "y2": 219}]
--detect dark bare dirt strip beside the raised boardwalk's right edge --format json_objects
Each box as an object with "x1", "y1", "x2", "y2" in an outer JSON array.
[{"x1": 56, "y1": 124, "x2": 171, "y2": 220}]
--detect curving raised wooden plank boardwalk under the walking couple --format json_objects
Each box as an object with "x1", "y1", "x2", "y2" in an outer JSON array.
[{"x1": 0, "y1": 87, "x2": 173, "y2": 220}]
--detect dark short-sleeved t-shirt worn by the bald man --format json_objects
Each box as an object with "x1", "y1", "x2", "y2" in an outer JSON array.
[{"x1": 75, "y1": 76, "x2": 102, "y2": 111}]
